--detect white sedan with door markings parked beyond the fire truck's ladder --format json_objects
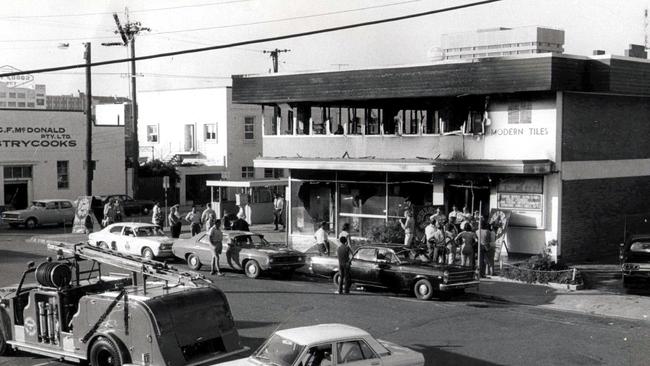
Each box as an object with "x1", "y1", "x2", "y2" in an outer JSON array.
[{"x1": 88, "y1": 222, "x2": 174, "y2": 259}]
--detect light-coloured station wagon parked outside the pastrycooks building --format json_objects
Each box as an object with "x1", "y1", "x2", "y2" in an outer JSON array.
[{"x1": 2, "y1": 199, "x2": 75, "y2": 229}]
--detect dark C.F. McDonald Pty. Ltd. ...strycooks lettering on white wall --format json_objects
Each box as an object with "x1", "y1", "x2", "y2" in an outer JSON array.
[{"x1": 0, "y1": 126, "x2": 77, "y2": 148}]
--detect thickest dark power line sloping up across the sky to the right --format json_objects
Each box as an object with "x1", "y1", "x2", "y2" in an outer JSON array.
[{"x1": 0, "y1": 0, "x2": 501, "y2": 77}]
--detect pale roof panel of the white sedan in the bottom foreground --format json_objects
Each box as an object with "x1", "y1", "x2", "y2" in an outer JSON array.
[{"x1": 275, "y1": 324, "x2": 370, "y2": 345}]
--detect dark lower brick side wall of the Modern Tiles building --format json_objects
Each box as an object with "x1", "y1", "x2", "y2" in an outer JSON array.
[{"x1": 560, "y1": 176, "x2": 650, "y2": 261}]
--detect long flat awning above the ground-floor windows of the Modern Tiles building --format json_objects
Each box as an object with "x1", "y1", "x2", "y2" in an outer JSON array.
[{"x1": 253, "y1": 157, "x2": 553, "y2": 175}]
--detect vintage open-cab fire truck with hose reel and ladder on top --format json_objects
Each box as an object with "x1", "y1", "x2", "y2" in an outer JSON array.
[{"x1": 0, "y1": 243, "x2": 246, "y2": 366}]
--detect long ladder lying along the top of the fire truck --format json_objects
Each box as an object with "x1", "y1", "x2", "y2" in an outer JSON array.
[{"x1": 47, "y1": 243, "x2": 212, "y2": 294}]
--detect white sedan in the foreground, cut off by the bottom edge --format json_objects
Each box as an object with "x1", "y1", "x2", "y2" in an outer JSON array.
[{"x1": 219, "y1": 324, "x2": 424, "y2": 366}]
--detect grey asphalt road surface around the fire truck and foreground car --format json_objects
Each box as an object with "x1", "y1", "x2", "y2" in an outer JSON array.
[{"x1": 0, "y1": 228, "x2": 650, "y2": 366}]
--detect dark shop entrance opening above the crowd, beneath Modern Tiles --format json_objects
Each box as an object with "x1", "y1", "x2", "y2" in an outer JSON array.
[{"x1": 445, "y1": 181, "x2": 490, "y2": 217}]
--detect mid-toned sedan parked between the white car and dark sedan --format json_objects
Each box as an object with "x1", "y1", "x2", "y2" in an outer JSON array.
[{"x1": 173, "y1": 231, "x2": 305, "y2": 278}]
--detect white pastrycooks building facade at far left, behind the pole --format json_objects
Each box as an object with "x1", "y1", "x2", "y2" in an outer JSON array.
[{"x1": 0, "y1": 109, "x2": 126, "y2": 208}]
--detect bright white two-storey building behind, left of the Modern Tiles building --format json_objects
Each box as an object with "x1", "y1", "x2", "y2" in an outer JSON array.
[{"x1": 138, "y1": 87, "x2": 274, "y2": 205}]
